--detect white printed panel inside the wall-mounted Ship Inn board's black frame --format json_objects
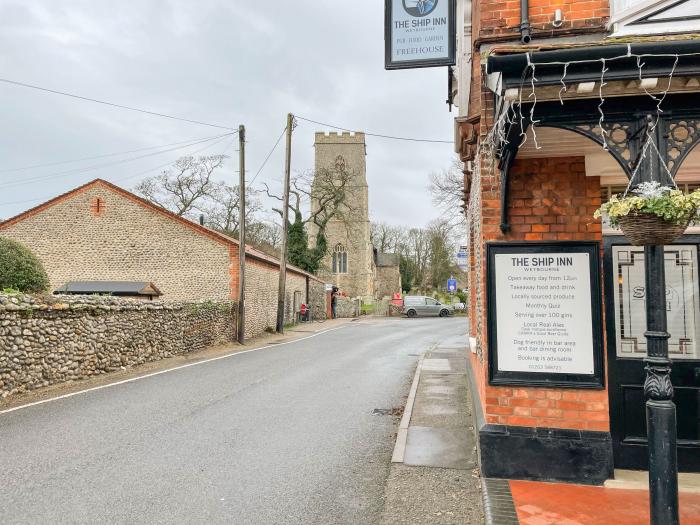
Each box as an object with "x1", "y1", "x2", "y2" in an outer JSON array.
[{"x1": 495, "y1": 252, "x2": 594, "y2": 375}]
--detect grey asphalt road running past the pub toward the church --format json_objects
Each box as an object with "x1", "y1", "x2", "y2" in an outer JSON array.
[{"x1": 0, "y1": 318, "x2": 466, "y2": 525}]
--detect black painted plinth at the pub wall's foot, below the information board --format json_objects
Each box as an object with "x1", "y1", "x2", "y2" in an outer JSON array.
[{"x1": 479, "y1": 425, "x2": 613, "y2": 485}]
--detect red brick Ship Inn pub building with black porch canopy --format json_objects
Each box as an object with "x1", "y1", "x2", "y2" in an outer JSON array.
[{"x1": 454, "y1": 0, "x2": 700, "y2": 483}]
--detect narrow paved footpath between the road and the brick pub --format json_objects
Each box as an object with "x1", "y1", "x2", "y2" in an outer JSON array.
[{"x1": 381, "y1": 332, "x2": 483, "y2": 525}]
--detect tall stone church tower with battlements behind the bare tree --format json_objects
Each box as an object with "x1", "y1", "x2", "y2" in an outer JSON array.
[{"x1": 309, "y1": 132, "x2": 375, "y2": 297}]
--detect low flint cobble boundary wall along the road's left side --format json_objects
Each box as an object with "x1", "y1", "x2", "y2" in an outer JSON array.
[{"x1": 0, "y1": 294, "x2": 236, "y2": 398}]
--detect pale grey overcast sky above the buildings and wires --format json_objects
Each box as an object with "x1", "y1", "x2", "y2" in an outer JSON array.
[{"x1": 0, "y1": 0, "x2": 454, "y2": 226}]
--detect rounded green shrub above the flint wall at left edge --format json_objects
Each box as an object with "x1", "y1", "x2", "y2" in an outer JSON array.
[{"x1": 0, "y1": 237, "x2": 49, "y2": 293}]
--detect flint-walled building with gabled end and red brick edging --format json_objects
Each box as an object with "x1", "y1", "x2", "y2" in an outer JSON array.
[{"x1": 0, "y1": 179, "x2": 325, "y2": 337}]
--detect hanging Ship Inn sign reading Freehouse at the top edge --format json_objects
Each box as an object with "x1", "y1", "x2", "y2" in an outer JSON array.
[{"x1": 384, "y1": 0, "x2": 456, "y2": 69}]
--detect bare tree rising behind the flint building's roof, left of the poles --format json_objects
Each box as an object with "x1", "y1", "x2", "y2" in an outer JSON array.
[{"x1": 135, "y1": 155, "x2": 225, "y2": 217}]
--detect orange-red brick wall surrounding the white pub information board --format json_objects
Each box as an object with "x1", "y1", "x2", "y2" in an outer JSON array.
[{"x1": 471, "y1": 157, "x2": 609, "y2": 431}]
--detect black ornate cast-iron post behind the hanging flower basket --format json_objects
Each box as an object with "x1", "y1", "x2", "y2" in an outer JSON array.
[{"x1": 640, "y1": 116, "x2": 679, "y2": 525}]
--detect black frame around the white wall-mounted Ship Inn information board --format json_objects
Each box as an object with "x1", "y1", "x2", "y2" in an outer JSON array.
[{"x1": 486, "y1": 241, "x2": 605, "y2": 390}]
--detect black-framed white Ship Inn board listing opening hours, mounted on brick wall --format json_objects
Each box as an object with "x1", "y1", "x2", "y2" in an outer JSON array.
[{"x1": 486, "y1": 242, "x2": 603, "y2": 388}]
